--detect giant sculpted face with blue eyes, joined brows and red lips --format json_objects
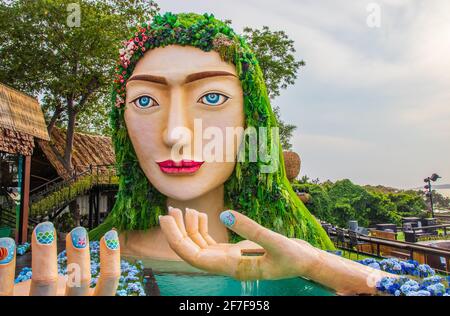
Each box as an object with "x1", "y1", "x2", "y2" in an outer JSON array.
[{"x1": 125, "y1": 45, "x2": 244, "y2": 201}]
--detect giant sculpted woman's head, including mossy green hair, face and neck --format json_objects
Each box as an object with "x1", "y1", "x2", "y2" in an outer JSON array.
[{"x1": 90, "y1": 13, "x2": 333, "y2": 251}]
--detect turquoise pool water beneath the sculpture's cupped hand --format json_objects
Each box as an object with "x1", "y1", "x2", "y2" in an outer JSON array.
[{"x1": 155, "y1": 273, "x2": 334, "y2": 296}]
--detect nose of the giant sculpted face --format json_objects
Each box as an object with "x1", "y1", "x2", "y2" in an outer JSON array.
[{"x1": 164, "y1": 88, "x2": 192, "y2": 148}]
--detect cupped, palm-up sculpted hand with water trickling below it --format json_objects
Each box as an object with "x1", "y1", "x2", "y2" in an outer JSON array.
[{"x1": 160, "y1": 208, "x2": 318, "y2": 280}]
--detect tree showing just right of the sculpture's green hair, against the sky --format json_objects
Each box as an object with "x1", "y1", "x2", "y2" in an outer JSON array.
[{"x1": 244, "y1": 26, "x2": 305, "y2": 150}]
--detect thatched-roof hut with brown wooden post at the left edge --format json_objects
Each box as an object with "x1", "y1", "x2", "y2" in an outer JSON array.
[{"x1": 0, "y1": 84, "x2": 49, "y2": 243}]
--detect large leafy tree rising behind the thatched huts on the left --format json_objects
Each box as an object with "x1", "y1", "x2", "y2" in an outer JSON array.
[{"x1": 0, "y1": 0, "x2": 159, "y2": 172}]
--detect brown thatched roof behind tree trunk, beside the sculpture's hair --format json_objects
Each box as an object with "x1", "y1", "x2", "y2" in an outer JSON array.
[{"x1": 38, "y1": 127, "x2": 115, "y2": 179}]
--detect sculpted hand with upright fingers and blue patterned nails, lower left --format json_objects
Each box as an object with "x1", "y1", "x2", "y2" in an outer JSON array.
[{"x1": 0, "y1": 222, "x2": 120, "y2": 296}]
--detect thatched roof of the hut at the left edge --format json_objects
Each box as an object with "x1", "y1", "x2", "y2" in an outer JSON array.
[{"x1": 0, "y1": 83, "x2": 49, "y2": 155}]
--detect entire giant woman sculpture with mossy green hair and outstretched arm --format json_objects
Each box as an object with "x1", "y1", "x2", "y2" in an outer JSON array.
[{"x1": 0, "y1": 13, "x2": 394, "y2": 295}]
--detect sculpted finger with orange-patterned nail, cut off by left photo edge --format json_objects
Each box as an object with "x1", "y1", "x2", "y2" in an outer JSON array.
[{"x1": 0, "y1": 238, "x2": 16, "y2": 296}]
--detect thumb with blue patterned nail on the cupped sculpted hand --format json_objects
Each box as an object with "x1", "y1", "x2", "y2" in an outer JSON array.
[{"x1": 220, "y1": 211, "x2": 290, "y2": 252}]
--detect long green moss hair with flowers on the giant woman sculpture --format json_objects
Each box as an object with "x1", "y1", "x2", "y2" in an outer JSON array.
[{"x1": 90, "y1": 13, "x2": 334, "y2": 250}]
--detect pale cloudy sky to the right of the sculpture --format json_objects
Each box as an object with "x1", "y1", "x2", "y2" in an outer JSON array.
[{"x1": 157, "y1": 0, "x2": 450, "y2": 188}]
